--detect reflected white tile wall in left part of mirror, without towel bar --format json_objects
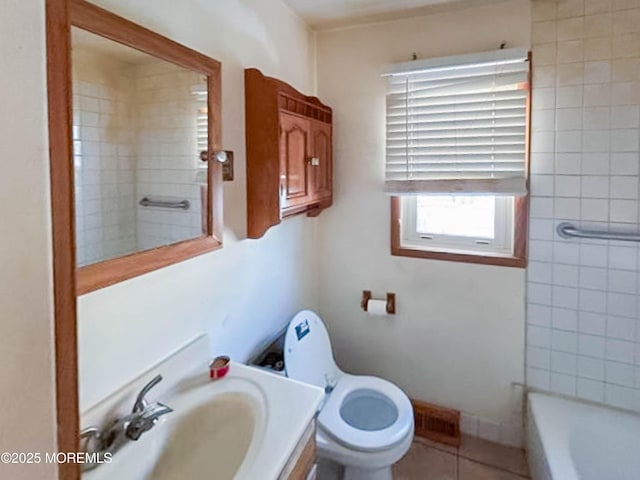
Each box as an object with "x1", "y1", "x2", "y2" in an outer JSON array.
[{"x1": 73, "y1": 49, "x2": 137, "y2": 266}]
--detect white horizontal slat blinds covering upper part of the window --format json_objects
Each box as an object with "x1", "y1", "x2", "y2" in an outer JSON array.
[{"x1": 384, "y1": 49, "x2": 529, "y2": 195}]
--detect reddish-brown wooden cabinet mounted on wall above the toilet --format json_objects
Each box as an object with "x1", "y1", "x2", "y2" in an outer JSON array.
[{"x1": 245, "y1": 68, "x2": 333, "y2": 238}]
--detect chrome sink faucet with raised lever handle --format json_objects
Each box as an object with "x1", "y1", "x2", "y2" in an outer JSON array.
[{"x1": 80, "y1": 375, "x2": 173, "y2": 471}]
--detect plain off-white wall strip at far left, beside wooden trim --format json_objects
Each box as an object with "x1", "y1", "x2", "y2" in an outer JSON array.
[{"x1": 0, "y1": 0, "x2": 57, "y2": 480}]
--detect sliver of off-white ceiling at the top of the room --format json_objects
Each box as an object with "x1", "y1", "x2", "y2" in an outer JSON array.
[{"x1": 284, "y1": 0, "x2": 504, "y2": 28}]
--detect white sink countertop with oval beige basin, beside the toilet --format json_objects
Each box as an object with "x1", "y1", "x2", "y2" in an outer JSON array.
[{"x1": 83, "y1": 363, "x2": 323, "y2": 480}]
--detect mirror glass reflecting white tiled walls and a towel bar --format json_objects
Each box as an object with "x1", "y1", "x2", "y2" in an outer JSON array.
[{"x1": 73, "y1": 29, "x2": 207, "y2": 266}]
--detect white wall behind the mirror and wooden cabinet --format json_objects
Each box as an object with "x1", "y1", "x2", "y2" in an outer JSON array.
[{"x1": 78, "y1": 0, "x2": 316, "y2": 410}]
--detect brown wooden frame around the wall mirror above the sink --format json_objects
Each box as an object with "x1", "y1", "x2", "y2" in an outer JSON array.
[{"x1": 49, "y1": 0, "x2": 223, "y2": 295}]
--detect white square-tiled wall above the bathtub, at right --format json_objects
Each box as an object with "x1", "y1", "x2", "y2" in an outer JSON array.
[{"x1": 526, "y1": 0, "x2": 640, "y2": 410}]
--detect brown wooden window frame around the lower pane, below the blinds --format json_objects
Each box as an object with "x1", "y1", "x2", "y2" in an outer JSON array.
[{"x1": 391, "y1": 195, "x2": 529, "y2": 268}]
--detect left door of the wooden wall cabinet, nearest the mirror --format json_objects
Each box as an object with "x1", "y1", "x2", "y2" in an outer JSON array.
[{"x1": 280, "y1": 113, "x2": 310, "y2": 208}]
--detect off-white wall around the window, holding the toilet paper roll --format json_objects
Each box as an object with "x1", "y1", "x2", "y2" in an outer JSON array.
[{"x1": 317, "y1": 1, "x2": 530, "y2": 443}]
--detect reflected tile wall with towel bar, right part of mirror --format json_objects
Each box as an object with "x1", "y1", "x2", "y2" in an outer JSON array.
[{"x1": 133, "y1": 61, "x2": 206, "y2": 250}]
